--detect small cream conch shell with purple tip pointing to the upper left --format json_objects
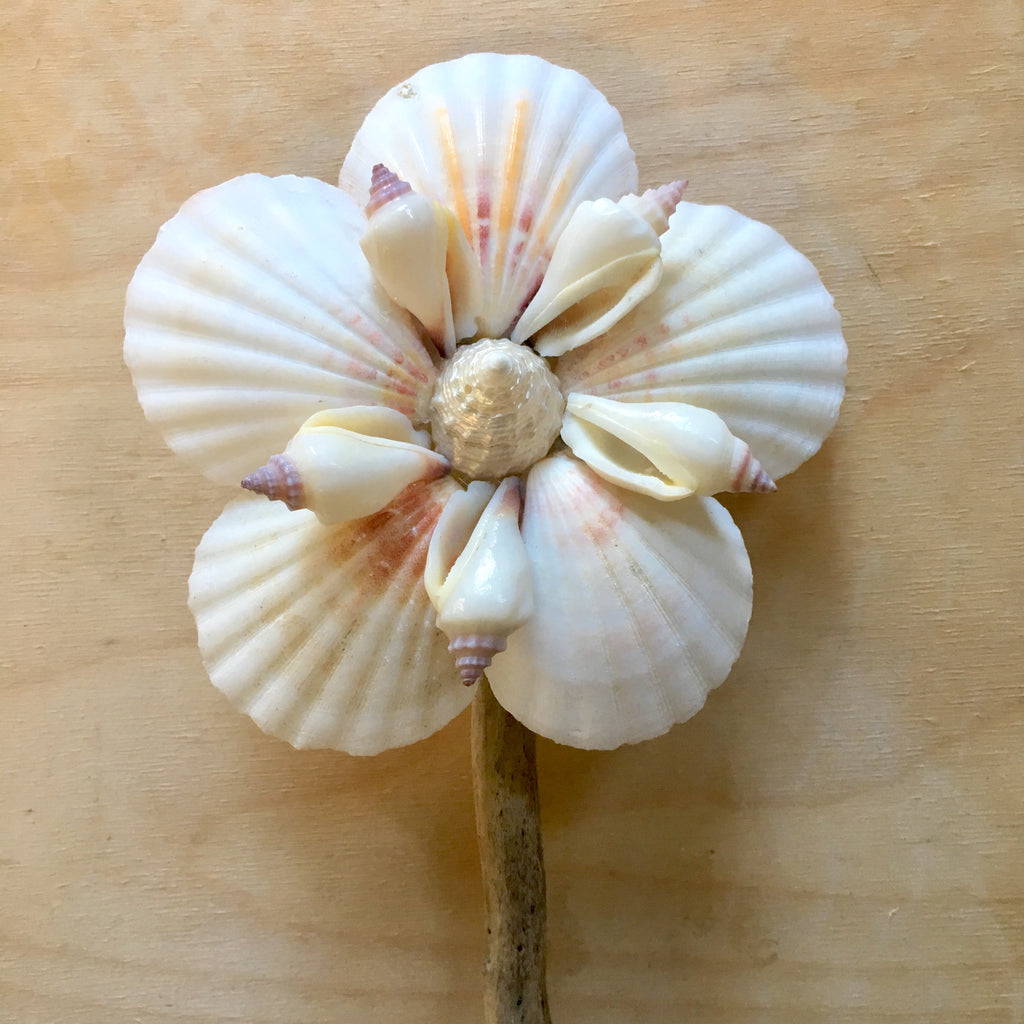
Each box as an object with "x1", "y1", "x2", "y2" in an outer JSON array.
[{"x1": 359, "y1": 164, "x2": 481, "y2": 356}]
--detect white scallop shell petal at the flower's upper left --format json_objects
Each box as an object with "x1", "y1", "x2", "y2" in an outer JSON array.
[{"x1": 125, "y1": 174, "x2": 435, "y2": 483}]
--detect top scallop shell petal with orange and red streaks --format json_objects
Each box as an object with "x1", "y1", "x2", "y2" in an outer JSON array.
[{"x1": 341, "y1": 53, "x2": 637, "y2": 338}]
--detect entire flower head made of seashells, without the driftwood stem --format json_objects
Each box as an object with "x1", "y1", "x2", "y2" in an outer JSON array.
[{"x1": 125, "y1": 54, "x2": 846, "y2": 754}]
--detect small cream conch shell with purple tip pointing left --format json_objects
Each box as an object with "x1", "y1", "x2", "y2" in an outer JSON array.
[{"x1": 242, "y1": 406, "x2": 450, "y2": 524}]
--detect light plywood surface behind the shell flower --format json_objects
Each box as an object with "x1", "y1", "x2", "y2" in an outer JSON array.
[{"x1": 0, "y1": 0, "x2": 1024, "y2": 1024}]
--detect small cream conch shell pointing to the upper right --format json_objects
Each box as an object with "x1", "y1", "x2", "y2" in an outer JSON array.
[{"x1": 512, "y1": 182, "x2": 685, "y2": 356}]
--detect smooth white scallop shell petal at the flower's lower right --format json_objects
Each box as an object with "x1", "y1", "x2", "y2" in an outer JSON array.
[{"x1": 487, "y1": 455, "x2": 752, "y2": 750}]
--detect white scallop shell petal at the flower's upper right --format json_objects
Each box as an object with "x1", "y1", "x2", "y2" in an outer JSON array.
[{"x1": 557, "y1": 203, "x2": 846, "y2": 479}]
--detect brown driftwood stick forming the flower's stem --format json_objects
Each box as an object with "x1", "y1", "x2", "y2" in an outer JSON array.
[{"x1": 473, "y1": 679, "x2": 551, "y2": 1024}]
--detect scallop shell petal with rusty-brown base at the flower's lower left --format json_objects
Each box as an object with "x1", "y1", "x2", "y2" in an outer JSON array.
[{"x1": 189, "y1": 478, "x2": 472, "y2": 754}]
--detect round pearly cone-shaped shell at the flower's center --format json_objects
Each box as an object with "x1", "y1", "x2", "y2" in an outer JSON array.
[{"x1": 430, "y1": 338, "x2": 565, "y2": 480}]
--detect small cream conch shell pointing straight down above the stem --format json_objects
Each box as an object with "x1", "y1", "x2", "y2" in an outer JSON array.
[{"x1": 423, "y1": 476, "x2": 534, "y2": 686}]
